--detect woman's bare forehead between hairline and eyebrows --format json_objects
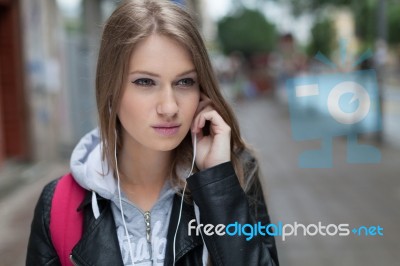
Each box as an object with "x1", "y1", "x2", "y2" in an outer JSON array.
[{"x1": 129, "y1": 34, "x2": 194, "y2": 75}]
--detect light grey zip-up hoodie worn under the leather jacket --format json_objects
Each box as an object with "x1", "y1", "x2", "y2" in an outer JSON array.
[{"x1": 71, "y1": 128, "x2": 175, "y2": 266}]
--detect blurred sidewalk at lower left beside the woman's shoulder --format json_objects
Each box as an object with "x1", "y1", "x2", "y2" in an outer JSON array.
[{"x1": 0, "y1": 161, "x2": 69, "y2": 266}]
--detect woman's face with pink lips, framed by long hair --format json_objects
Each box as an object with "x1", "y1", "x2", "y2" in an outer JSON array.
[{"x1": 118, "y1": 34, "x2": 200, "y2": 151}]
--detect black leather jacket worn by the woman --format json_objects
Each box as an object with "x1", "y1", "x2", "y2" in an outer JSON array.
[{"x1": 26, "y1": 162, "x2": 279, "y2": 266}]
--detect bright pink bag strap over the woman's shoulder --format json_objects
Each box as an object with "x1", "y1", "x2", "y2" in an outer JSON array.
[{"x1": 50, "y1": 173, "x2": 85, "y2": 266}]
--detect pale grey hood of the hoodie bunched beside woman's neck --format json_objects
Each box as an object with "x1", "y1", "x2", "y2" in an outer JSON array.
[{"x1": 70, "y1": 128, "x2": 117, "y2": 199}]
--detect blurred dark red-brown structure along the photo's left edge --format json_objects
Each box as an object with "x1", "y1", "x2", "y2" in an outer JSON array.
[{"x1": 0, "y1": 0, "x2": 31, "y2": 163}]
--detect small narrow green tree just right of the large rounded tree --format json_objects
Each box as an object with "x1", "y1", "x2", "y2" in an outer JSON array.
[{"x1": 307, "y1": 18, "x2": 336, "y2": 57}]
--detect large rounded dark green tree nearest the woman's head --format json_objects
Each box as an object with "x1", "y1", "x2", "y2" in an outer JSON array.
[{"x1": 218, "y1": 8, "x2": 277, "y2": 56}]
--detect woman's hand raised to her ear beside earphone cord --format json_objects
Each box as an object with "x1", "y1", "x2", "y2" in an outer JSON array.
[{"x1": 192, "y1": 93, "x2": 231, "y2": 170}]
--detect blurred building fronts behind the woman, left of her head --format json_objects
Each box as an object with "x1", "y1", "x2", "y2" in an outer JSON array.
[{"x1": 0, "y1": 0, "x2": 203, "y2": 165}]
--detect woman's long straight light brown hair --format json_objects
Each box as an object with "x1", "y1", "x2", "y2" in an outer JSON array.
[{"x1": 96, "y1": 0, "x2": 260, "y2": 191}]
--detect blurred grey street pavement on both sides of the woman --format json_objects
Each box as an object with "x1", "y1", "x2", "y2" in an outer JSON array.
[{"x1": 0, "y1": 93, "x2": 400, "y2": 266}]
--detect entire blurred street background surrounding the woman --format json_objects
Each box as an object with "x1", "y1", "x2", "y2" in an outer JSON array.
[{"x1": 0, "y1": 0, "x2": 400, "y2": 266}]
